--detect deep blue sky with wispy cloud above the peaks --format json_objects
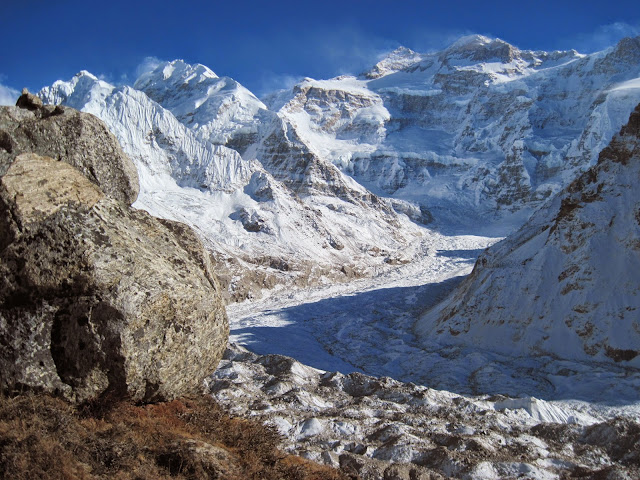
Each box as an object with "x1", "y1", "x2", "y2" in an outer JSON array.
[{"x1": 0, "y1": 0, "x2": 640, "y2": 99}]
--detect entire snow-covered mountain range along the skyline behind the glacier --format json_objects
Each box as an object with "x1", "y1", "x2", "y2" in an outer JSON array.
[{"x1": 40, "y1": 35, "x2": 640, "y2": 298}]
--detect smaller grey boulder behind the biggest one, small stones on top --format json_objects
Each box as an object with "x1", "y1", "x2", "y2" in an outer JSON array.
[{"x1": 0, "y1": 91, "x2": 139, "y2": 205}]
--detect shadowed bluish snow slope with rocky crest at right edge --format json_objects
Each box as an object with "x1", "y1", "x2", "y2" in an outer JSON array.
[{"x1": 416, "y1": 105, "x2": 640, "y2": 367}]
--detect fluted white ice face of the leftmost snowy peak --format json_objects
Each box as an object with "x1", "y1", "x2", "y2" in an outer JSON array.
[{"x1": 40, "y1": 71, "x2": 252, "y2": 191}]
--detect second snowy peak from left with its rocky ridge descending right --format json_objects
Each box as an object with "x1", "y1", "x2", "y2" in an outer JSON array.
[{"x1": 135, "y1": 60, "x2": 400, "y2": 209}]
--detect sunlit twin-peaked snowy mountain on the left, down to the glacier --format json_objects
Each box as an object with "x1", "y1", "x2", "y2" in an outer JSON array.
[{"x1": 40, "y1": 70, "x2": 423, "y2": 299}]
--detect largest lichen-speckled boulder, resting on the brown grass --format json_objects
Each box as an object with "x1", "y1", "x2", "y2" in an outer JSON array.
[{"x1": 0, "y1": 108, "x2": 229, "y2": 402}]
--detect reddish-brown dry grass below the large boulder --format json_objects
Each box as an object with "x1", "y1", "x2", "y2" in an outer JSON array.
[{"x1": 0, "y1": 394, "x2": 348, "y2": 480}]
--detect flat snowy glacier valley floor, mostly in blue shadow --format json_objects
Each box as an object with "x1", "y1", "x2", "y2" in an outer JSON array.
[{"x1": 227, "y1": 229, "x2": 640, "y2": 421}]
